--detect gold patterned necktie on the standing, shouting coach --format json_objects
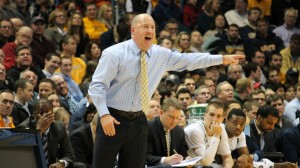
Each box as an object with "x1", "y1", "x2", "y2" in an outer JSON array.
[{"x1": 141, "y1": 50, "x2": 149, "y2": 113}]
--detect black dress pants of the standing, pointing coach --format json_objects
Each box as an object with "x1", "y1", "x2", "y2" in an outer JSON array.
[{"x1": 93, "y1": 109, "x2": 148, "y2": 168}]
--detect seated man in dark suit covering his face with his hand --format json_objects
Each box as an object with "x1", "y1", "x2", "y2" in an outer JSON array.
[{"x1": 34, "y1": 98, "x2": 75, "y2": 168}]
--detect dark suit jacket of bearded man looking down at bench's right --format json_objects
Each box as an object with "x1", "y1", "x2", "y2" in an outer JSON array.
[{"x1": 250, "y1": 120, "x2": 278, "y2": 152}]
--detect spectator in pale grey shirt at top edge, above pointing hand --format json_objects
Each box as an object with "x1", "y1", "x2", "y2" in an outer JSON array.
[{"x1": 225, "y1": 0, "x2": 248, "y2": 27}]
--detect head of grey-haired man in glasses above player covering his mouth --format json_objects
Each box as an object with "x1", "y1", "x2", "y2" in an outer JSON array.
[{"x1": 194, "y1": 85, "x2": 211, "y2": 104}]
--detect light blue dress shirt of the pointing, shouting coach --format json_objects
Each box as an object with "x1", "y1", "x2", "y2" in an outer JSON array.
[{"x1": 89, "y1": 40, "x2": 223, "y2": 117}]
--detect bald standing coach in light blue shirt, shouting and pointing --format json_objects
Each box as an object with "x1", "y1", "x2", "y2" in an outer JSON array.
[{"x1": 89, "y1": 14, "x2": 244, "y2": 168}]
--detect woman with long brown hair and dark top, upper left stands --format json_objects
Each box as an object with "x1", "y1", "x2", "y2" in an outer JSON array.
[{"x1": 67, "y1": 12, "x2": 90, "y2": 57}]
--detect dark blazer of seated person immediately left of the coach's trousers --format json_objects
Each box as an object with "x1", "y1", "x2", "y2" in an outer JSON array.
[{"x1": 70, "y1": 123, "x2": 94, "y2": 168}]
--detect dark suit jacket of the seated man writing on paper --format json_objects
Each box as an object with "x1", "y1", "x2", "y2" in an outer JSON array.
[{"x1": 147, "y1": 117, "x2": 187, "y2": 166}]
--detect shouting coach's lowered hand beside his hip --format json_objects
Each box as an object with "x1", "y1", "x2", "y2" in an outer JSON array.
[{"x1": 100, "y1": 114, "x2": 120, "y2": 136}]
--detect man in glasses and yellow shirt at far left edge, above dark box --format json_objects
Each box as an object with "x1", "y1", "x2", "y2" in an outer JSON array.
[{"x1": 0, "y1": 90, "x2": 15, "y2": 128}]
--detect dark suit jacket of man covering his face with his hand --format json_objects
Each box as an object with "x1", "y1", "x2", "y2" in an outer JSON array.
[{"x1": 48, "y1": 121, "x2": 75, "y2": 167}]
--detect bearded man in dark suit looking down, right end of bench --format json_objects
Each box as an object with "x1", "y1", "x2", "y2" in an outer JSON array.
[{"x1": 250, "y1": 105, "x2": 279, "y2": 152}]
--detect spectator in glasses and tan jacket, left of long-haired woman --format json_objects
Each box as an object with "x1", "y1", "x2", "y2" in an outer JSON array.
[{"x1": 44, "y1": 9, "x2": 67, "y2": 53}]
